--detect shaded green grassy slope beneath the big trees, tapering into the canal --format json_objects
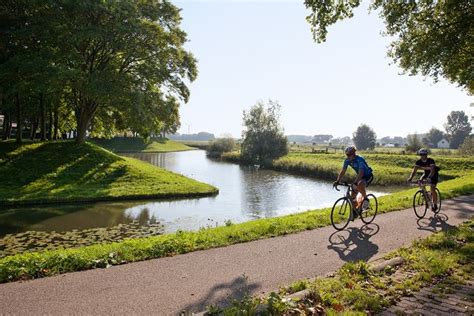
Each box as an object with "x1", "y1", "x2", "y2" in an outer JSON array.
[{"x1": 0, "y1": 142, "x2": 217, "y2": 206}]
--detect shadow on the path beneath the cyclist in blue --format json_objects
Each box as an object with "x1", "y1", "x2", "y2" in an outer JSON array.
[{"x1": 328, "y1": 223, "x2": 380, "y2": 262}]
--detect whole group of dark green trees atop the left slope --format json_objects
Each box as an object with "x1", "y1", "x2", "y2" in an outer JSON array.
[{"x1": 0, "y1": 0, "x2": 197, "y2": 143}]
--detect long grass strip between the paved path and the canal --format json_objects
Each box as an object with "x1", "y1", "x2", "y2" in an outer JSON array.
[{"x1": 0, "y1": 172, "x2": 474, "y2": 282}]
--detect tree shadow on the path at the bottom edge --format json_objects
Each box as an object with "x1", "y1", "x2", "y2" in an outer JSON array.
[{"x1": 184, "y1": 274, "x2": 260, "y2": 315}]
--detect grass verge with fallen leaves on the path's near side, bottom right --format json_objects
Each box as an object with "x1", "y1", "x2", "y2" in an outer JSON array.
[{"x1": 212, "y1": 220, "x2": 474, "y2": 315}]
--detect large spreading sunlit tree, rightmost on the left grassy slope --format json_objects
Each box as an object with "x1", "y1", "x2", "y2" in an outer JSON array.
[{"x1": 59, "y1": 0, "x2": 197, "y2": 142}]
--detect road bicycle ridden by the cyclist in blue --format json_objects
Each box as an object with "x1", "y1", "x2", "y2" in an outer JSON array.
[{"x1": 331, "y1": 182, "x2": 379, "y2": 230}]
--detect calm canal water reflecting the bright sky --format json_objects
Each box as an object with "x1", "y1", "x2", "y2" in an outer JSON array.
[{"x1": 0, "y1": 150, "x2": 392, "y2": 237}]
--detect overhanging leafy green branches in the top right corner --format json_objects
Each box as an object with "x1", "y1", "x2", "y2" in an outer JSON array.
[{"x1": 305, "y1": 0, "x2": 474, "y2": 94}]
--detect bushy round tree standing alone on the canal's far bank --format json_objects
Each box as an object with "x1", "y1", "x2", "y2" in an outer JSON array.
[{"x1": 241, "y1": 100, "x2": 288, "y2": 166}]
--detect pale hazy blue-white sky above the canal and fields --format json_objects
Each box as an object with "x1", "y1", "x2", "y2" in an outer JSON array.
[{"x1": 175, "y1": 0, "x2": 474, "y2": 138}]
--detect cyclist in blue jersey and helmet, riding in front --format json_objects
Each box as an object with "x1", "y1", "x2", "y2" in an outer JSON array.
[{"x1": 334, "y1": 146, "x2": 374, "y2": 210}]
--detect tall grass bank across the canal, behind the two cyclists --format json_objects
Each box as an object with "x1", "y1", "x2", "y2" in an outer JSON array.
[{"x1": 223, "y1": 152, "x2": 474, "y2": 185}]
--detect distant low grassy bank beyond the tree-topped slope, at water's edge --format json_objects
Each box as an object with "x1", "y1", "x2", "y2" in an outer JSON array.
[{"x1": 90, "y1": 137, "x2": 194, "y2": 153}]
